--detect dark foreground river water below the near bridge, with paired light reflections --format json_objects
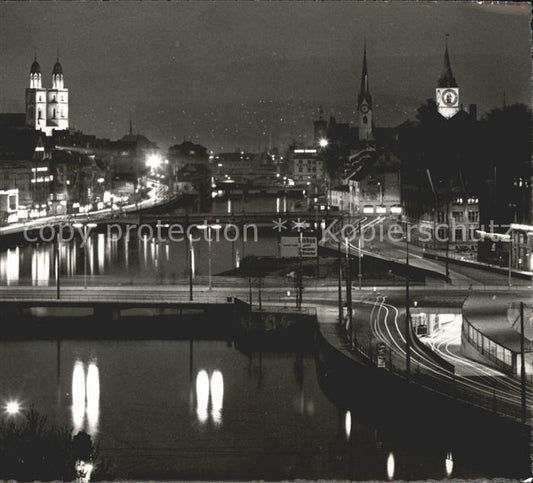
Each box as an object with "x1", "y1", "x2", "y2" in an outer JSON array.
[{"x1": 0, "y1": 334, "x2": 516, "y2": 480}]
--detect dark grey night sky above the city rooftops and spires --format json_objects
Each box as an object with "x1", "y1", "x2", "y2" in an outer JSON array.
[{"x1": 0, "y1": 2, "x2": 531, "y2": 151}]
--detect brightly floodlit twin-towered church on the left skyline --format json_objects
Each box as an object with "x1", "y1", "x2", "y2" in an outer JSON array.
[{"x1": 26, "y1": 56, "x2": 69, "y2": 136}]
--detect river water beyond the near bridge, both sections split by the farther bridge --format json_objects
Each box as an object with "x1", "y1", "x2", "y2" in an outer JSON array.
[{"x1": 0, "y1": 196, "x2": 314, "y2": 286}]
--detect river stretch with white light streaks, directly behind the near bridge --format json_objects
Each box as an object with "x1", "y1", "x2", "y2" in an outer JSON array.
[{"x1": 0, "y1": 233, "x2": 278, "y2": 286}]
